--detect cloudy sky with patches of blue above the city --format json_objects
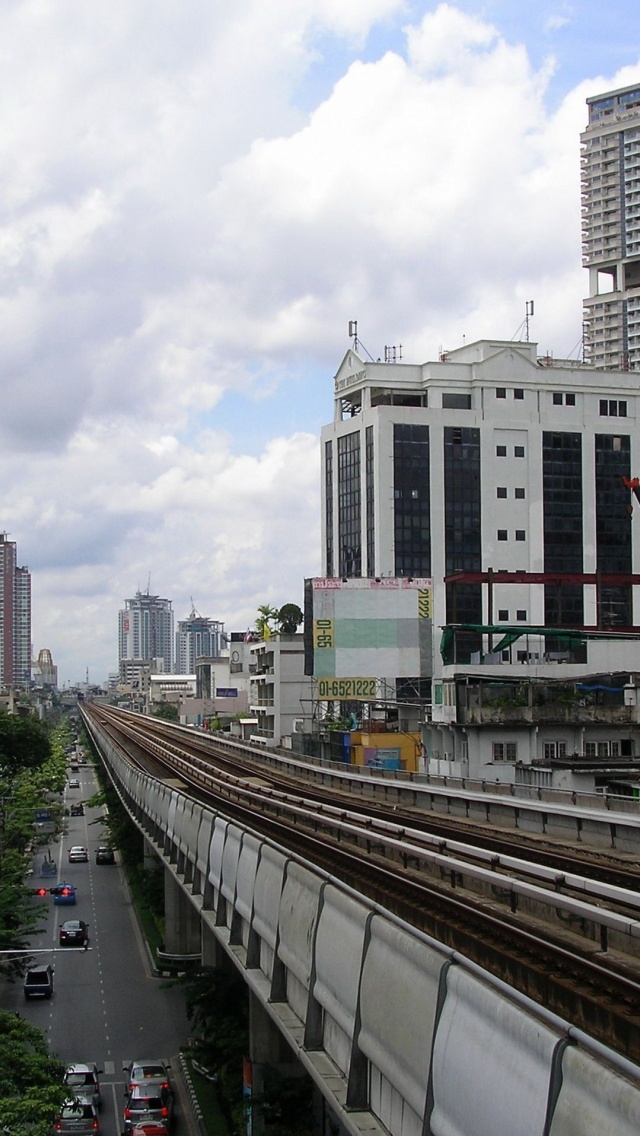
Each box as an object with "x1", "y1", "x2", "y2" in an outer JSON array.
[{"x1": 0, "y1": 0, "x2": 640, "y2": 685}]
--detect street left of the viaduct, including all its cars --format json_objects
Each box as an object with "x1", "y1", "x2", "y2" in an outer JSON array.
[{"x1": 0, "y1": 749, "x2": 198, "y2": 1136}]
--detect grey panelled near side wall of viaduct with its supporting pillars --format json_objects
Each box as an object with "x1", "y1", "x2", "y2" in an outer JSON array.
[{"x1": 84, "y1": 717, "x2": 640, "y2": 1136}]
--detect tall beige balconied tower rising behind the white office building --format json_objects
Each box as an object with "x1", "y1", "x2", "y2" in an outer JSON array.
[{"x1": 581, "y1": 83, "x2": 640, "y2": 370}]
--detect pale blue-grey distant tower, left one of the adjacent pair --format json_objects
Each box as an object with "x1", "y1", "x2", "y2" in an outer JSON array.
[{"x1": 118, "y1": 592, "x2": 174, "y2": 680}]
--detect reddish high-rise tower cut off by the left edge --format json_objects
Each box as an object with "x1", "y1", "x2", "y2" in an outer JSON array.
[{"x1": 0, "y1": 533, "x2": 31, "y2": 688}]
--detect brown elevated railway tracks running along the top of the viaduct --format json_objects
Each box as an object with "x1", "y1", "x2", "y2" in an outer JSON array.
[{"x1": 85, "y1": 705, "x2": 640, "y2": 1061}]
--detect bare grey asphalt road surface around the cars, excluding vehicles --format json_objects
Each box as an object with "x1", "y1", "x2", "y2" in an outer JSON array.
[{"x1": 0, "y1": 766, "x2": 197, "y2": 1136}]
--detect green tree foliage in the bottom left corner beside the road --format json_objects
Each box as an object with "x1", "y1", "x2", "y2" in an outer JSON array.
[{"x1": 0, "y1": 1010, "x2": 67, "y2": 1136}]
